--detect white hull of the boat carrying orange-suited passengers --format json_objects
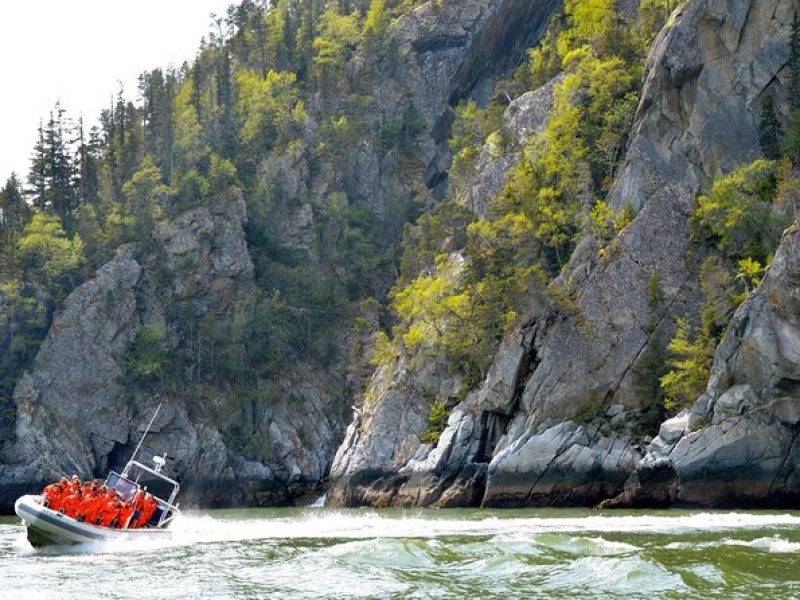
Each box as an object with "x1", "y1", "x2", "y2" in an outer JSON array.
[{"x1": 14, "y1": 495, "x2": 169, "y2": 547}]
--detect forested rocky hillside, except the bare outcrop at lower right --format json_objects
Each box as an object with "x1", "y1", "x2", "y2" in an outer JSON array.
[{"x1": 0, "y1": 0, "x2": 800, "y2": 506}]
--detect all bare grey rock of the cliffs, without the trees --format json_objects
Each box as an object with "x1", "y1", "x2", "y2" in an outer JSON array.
[{"x1": 0, "y1": 0, "x2": 800, "y2": 513}]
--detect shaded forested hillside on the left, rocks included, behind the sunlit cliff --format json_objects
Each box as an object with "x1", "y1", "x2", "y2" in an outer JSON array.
[{"x1": 0, "y1": 0, "x2": 557, "y2": 508}]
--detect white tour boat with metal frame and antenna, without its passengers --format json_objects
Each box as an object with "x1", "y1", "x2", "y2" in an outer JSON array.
[{"x1": 14, "y1": 405, "x2": 180, "y2": 547}]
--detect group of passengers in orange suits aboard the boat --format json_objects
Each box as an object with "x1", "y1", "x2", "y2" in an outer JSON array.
[{"x1": 42, "y1": 475, "x2": 158, "y2": 529}]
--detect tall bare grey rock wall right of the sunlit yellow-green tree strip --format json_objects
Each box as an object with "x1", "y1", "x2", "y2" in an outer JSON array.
[{"x1": 329, "y1": 0, "x2": 793, "y2": 506}]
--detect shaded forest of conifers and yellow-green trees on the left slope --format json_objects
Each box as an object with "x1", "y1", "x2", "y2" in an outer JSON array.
[{"x1": 0, "y1": 0, "x2": 422, "y2": 446}]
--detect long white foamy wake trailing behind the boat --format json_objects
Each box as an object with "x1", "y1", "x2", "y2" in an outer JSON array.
[{"x1": 10, "y1": 509, "x2": 800, "y2": 555}]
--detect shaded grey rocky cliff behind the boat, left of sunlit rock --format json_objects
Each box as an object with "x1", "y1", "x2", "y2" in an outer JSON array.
[{"x1": 0, "y1": 0, "x2": 560, "y2": 511}]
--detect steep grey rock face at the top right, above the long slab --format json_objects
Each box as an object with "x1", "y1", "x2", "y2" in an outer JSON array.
[{"x1": 611, "y1": 0, "x2": 794, "y2": 208}]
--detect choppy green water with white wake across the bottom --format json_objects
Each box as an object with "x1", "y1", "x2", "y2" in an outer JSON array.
[{"x1": 0, "y1": 509, "x2": 800, "y2": 599}]
